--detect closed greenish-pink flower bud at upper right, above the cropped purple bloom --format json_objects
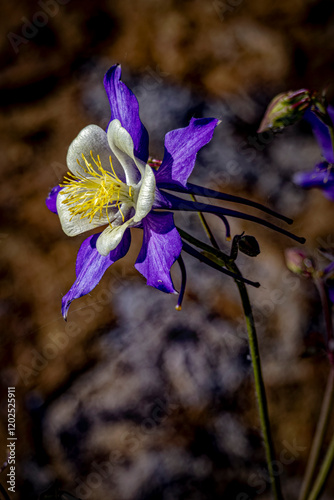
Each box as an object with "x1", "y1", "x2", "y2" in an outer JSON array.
[{"x1": 258, "y1": 89, "x2": 314, "y2": 133}]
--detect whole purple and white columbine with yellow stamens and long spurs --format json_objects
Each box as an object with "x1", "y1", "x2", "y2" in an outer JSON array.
[{"x1": 46, "y1": 65, "x2": 303, "y2": 318}]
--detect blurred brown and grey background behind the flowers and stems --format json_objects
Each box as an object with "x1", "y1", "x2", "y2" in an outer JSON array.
[{"x1": 0, "y1": 0, "x2": 334, "y2": 500}]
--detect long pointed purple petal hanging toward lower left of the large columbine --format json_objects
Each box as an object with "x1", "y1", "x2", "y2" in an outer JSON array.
[{"x1": 62, "y1": 230, "x2": 131, "y2": 319}]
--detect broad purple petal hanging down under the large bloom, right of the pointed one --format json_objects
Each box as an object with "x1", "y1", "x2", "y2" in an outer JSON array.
[{"x1": 135, "y1": 212, "x2": 182, "y2": 293}]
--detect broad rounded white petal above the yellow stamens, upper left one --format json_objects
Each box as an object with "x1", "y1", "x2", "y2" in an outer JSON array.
[{"x1": 66, "y1": 125, "x2": 125, "y2": 180}]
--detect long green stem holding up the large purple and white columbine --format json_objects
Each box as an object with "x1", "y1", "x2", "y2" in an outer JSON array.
[{"x1": 177, "y1": 228, "x2": 283, "y2": 500}]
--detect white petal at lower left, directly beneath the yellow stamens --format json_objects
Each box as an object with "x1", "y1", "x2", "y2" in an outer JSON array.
[{"x1": 57, "y1": 190, "x2": 118, "y2": 236}]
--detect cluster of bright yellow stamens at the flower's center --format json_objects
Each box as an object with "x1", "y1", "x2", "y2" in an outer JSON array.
[{"x1": 60, "y1": 151, "x2": 134, "y2": 226}]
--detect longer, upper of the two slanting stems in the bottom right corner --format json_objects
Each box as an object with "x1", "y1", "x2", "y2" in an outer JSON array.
[{"x1": 299, "y1": 367, "x2": 334, "y2": 500}]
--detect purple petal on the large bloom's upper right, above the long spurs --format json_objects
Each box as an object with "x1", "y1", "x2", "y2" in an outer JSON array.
[{"x1": 156, "y1": 118, "x2": 219, "y2": 187}]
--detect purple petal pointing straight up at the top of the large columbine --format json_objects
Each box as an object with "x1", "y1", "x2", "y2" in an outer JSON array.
[{"x1": 103, "y1": 64, "x2": 148, "y2": 163}]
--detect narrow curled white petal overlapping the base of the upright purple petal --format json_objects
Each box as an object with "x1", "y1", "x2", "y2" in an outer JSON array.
[{"x1": 107, "y1": 120, "x2": 145, "y2": 186}]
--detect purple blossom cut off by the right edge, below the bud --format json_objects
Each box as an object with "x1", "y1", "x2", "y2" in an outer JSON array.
[{"x1": 293, "y1": 106, "x2": 334, "y2": 201}]
